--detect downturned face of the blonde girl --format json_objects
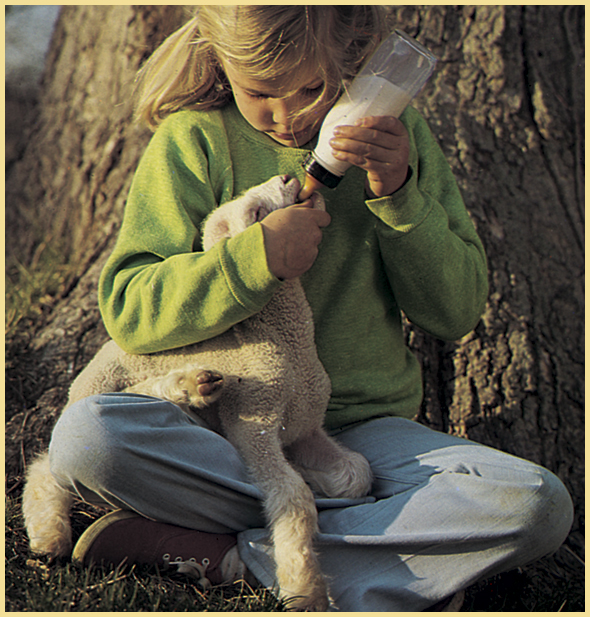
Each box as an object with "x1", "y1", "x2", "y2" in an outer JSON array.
[{"x1": 223, "y1": 62, "x2": 330, "y2": 148}]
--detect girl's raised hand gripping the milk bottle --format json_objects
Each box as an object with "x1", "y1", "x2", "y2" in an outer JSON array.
[{"x1": 330, "y1": 116, "x2": 410, "y2": 198}]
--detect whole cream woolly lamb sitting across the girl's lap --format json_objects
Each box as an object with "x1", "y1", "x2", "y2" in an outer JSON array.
[{"x1": 23, "y1": 176, "x2": 372, "y2": 611}]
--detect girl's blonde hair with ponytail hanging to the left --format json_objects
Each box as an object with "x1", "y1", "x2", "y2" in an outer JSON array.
[{"x1": 135, "y1": 5, "x2": 387, "y2": 129}]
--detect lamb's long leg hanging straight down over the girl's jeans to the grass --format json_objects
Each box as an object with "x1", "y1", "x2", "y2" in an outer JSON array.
[{"x1": 226, "y1": 422, "x2": 329, "y2": 611}]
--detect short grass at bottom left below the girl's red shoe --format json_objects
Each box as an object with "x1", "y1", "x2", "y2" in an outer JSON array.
[{"x1": 5, "y1": 498, "x2": 286, "y2": 612}]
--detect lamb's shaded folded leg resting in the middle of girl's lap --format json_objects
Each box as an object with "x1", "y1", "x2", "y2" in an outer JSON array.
[{"x1": 285, "y1": 429, "x2": 373, "y2": 498}]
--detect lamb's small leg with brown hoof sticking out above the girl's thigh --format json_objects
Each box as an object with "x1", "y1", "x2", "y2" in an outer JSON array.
[{"x1": 125, "y1": 366, "x2": 224, "y2": 411}]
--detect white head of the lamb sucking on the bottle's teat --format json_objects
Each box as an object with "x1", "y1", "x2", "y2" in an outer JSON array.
[{"x1": 203, "y1": 175, "x2": 325, "y2": 251}]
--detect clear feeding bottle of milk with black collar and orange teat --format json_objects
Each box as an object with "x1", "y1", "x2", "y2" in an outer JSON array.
[{"x1": 299, "y1": 30, "x2": 436, "y2": 201}]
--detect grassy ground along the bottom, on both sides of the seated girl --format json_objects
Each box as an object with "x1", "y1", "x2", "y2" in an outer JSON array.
[{"x1": 5, "y1": 485, "x2": 584, "y2": 612}]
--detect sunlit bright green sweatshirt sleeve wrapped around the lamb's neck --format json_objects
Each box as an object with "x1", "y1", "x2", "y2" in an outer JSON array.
[{"x1": 99, "y1": 112, "x2": 280, "y2": 353}]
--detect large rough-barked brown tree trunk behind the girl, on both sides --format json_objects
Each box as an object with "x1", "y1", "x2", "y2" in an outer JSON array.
[{"x1": 6, "y1": 6, "x2": 584, "y2": 545}]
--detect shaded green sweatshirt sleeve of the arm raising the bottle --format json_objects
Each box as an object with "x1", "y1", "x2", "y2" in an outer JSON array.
[{"x1": 367, "y1": 108, "x2": 488, "y2": 340}]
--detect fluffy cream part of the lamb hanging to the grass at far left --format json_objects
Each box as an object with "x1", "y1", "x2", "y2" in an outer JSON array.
[{"x1": 22, "y1": 453, "x2": 73, "y2": 556}]
